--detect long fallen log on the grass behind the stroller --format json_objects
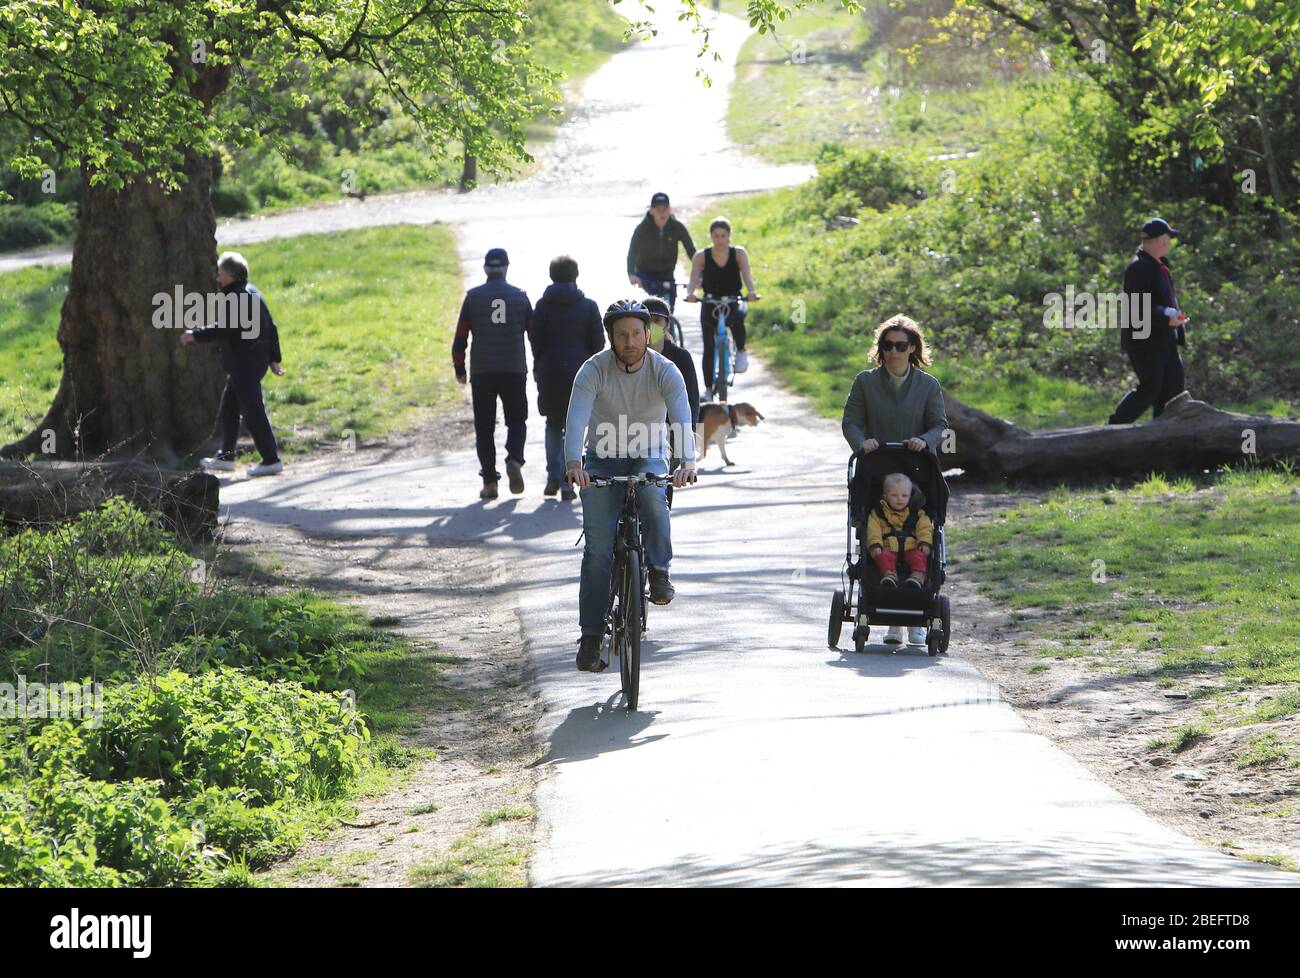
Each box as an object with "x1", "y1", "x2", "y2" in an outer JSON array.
[{"x1": 940, "y1": 390, "x2": 1300, "y2": 479}]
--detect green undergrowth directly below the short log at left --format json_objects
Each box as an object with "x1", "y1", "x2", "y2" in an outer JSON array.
[{"x1": 0, "y1": 499, "x2": 378, "y2": 689}]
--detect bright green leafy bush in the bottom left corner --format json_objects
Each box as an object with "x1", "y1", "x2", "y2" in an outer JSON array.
[{"x1": 0, "y1": 670, "x2": 369, "y2": 886}]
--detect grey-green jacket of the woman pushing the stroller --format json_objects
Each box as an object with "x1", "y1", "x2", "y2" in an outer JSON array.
[{"x1": 840, "y1": 367, "x2": 948, "y2": 455}]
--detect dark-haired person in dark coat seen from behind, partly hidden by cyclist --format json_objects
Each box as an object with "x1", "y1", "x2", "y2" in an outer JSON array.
[{"x1": 533, "y1": 255, "x2": 605, "y2": 499}]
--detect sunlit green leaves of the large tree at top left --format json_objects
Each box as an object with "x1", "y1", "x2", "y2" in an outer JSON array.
[{"x1": 0, "y1": 0, "x2": 558, "y2": 189}]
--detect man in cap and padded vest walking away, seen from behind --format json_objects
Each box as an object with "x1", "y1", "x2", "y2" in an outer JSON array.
[{"x1": 451, "y1": 248, "x2": 536, "y2": 499}]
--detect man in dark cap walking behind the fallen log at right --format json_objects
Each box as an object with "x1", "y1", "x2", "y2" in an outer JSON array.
[{"x1": 1106, "y1": 217, "x2": 1187, "y2": 424}]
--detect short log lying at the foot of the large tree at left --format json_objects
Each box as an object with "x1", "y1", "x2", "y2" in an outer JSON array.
[{"x1": 0, "y1": 462, "x2": 220, "y2": 540}]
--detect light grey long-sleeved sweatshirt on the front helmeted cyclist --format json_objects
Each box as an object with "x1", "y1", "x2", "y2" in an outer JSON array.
[{"x1": 564, "y1": 350, "x2": 696, "y2": 463}]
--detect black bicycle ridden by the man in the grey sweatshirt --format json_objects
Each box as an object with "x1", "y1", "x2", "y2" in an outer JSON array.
[{"x1": 590, "y1": 472, "x2": 672, "y2": 713}]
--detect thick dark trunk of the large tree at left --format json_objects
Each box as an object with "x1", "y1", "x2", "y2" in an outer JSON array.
[{"x1": 0, "y1": 146, "x2": 222, "y2": 464}]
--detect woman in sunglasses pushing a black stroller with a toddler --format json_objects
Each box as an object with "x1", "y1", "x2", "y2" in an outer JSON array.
[{"x1": 841, "y1": 315, "x2": 948, "y2": 645}]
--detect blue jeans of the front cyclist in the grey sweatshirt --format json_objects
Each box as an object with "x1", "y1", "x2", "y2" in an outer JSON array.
[{"x1": 577, "y1": 455, "x2": 672, "y2": 635}]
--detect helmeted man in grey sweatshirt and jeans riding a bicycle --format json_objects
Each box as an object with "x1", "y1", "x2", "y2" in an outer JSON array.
[{"x1": 564, "y1": 299, "x2": 697, "y2": 672}]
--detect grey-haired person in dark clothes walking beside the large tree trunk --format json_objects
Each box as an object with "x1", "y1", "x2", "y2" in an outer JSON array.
[{"x1": 181, "y1": 251, "x2": 285, "y2": 476}]
